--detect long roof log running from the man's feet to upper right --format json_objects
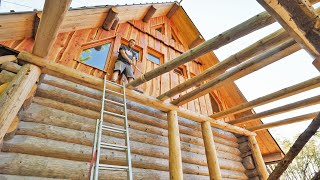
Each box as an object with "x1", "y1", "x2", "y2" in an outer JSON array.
[{"x1": 127, "y1": 12, "x2": 275, "y2": 88}]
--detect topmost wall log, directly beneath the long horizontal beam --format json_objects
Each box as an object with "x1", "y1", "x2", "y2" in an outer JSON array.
[{"x1": 42, "y1": 75, "x2": 238, "y2": 142}]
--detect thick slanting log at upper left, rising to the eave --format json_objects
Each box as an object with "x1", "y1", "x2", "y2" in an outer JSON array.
[{"x1": 32, "y1": 0, "x2": 71, "y2": 58}]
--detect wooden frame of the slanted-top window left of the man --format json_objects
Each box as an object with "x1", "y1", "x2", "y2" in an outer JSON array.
[{"x1": 75, "y1": 37, "x2": 115, "y2": 72}]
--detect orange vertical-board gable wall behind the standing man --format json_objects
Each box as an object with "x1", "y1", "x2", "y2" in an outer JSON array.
[{"x1": 0, "y1": 16, "x2": 218, "y2": 115}]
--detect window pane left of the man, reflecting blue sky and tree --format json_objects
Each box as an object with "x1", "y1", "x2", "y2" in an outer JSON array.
[{"x1": 80, "y1": 43, "x2": 111, "y2": 70}]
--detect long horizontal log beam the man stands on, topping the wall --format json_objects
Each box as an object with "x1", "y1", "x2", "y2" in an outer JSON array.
[{"x1": 18, "y1": 52, "x2": 255, "y2": 136}]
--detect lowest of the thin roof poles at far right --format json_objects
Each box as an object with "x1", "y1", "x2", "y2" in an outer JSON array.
[{"x1": 248, "y1": 112, "x2": 319, "y2": 131}]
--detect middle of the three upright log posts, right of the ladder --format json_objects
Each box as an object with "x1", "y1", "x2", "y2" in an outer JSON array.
[{"x1": 201, "y1": 121, "x2": 222, "y2": 180}]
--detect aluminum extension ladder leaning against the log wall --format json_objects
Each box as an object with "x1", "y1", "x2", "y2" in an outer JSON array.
[{"x1": 90, "y1": 76, "x2": 132, "y2": 180}]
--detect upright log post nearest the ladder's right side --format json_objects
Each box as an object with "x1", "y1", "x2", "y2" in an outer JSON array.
[{"x1": 168, "y1": 111, "x2": 183, "y2": 180}]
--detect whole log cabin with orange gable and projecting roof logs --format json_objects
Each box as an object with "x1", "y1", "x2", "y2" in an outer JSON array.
[{"x1": 0, "y1": 0, "x2": 320, "y2": 179}]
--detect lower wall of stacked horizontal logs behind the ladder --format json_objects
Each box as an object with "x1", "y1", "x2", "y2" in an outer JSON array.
[{"x1": 0, "y1": 70, "x2": 247, "y2": 179}]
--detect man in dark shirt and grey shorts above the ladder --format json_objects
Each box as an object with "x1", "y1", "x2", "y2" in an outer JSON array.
[{"x1": 111, "y1": 39, "x2": 137, "y2": 83}]
